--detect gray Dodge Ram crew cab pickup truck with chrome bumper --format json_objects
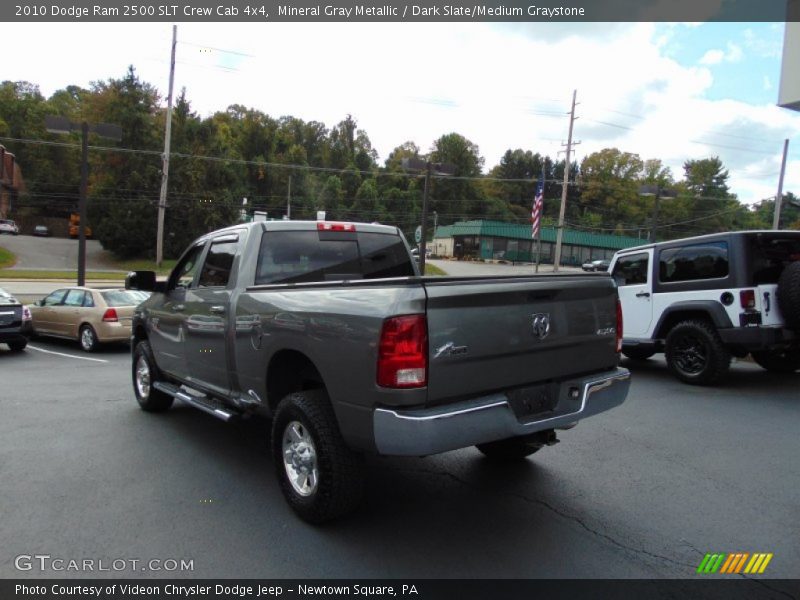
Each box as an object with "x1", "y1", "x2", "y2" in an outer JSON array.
[{"x1": 126, "y1": 221, "x2": 630, "y2": 523}]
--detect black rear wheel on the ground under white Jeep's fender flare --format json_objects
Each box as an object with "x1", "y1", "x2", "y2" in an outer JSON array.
[{"x1": 664, "y1": 320, "x2": 731, "y2": 385}]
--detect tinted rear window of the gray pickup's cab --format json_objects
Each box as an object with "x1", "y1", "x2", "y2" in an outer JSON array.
[{"x1": 255, "y1": 231, "x2": 415, "y2": 285}]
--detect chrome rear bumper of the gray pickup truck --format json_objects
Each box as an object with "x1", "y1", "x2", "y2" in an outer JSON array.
[{"x1": 373, "y1": 368, "x2": 630, "y2": 456}]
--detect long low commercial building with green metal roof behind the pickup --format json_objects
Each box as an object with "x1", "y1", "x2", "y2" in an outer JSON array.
[{"x1": 430, "y1": 221, "x2": 648, "y2": 265}]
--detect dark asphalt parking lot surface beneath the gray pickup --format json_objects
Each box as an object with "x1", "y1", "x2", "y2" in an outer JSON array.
[{"x1": 0, "y1": 340, "x2": 800, "y2": 597}]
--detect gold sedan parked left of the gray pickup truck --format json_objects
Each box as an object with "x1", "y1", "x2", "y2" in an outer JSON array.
[{"x1": 31, "y1": 287, "x2": 149, "y2": 352}]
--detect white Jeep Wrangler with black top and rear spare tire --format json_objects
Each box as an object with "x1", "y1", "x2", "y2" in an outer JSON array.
[{"x1": 609, "y1": 231, "x2": 800, "y2": 385}]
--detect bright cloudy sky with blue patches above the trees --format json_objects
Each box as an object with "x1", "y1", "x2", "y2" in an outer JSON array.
[{"x1": 0, "y1": 23, "x2": 800, "y2": 203}]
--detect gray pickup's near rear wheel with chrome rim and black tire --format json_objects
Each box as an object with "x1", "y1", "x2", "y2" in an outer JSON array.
[{"x1": 272, "y1": 390, "x2": 364, "y2": 524}]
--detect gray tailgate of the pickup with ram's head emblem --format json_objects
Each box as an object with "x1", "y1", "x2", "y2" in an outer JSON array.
[{"x1": 424, "y1": 274, "x2": 617, "y2": 405}]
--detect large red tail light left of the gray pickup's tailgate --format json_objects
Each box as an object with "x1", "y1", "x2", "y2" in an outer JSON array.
[{"x1": 377, "y1": 315, "x2": 428, "y2": 388}]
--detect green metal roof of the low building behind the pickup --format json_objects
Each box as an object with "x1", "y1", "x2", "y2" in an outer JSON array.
[{"x1": 435, "y1": 221, "x2": 647, "y2": 250}]
